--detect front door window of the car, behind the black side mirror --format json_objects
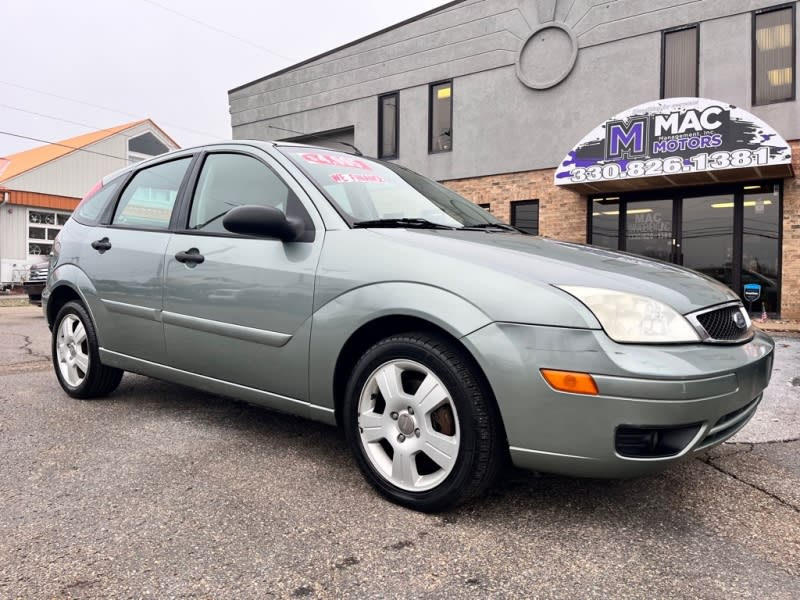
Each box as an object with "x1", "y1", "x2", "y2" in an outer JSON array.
[{"x1": 189, "y1": 154, "x2": 299, "y2": 232}]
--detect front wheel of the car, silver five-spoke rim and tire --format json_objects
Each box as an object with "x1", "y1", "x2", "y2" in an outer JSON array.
[{"x1": 343, "y1": 333, "x2": 505, "y2": 511}]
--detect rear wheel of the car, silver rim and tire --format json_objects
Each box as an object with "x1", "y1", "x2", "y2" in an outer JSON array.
[{"x1": 52, "y1": 301, "x2": 123, "y2": 398}]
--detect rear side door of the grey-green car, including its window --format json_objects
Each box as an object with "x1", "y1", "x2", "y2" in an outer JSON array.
[{"x1": 81, "y1": 156, "x2": 192, "y2": 363}]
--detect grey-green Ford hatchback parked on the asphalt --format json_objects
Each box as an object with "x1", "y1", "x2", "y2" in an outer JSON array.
[{"x1": 43, "y1": 142, "x2": 774, "y2": 511}]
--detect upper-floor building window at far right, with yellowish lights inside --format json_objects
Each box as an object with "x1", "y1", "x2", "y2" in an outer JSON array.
[{"x1": 753, "y1": 6, "x2": 795, "y2": 104}]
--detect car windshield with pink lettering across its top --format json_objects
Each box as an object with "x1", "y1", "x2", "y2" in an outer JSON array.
[{"x1": 279, "y1": 146, "x2": 503, "y2": 228}]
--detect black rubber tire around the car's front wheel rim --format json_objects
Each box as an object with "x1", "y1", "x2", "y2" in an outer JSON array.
[{"x1": 342, "y1": 332, "x2": 508, "y2": 512}]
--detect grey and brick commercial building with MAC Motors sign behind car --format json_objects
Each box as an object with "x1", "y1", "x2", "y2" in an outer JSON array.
[{"x1": 229, "y1": 0, "x2": 800, "y2": 318}]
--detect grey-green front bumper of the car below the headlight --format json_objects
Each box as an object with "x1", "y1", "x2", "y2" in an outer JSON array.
[{"x1": 462, "y1": 323, "x2": 774, "y2": 478}]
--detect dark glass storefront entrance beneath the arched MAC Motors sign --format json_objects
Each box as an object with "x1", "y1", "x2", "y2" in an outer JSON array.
[{"x1": 589, "y1": 182, "x2": 781, "y2": 315}]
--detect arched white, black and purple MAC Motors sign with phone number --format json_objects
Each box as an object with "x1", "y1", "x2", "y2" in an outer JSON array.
[{"x1": 555, "y1": 98, "x2": 792, "y2": 185}]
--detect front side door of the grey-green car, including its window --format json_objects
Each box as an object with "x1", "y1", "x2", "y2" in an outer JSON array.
[{"x1": 163, "y1": 149, "x2": 324, "y2": 400}]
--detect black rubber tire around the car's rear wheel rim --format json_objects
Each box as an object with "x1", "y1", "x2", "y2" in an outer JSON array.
[{"x1": 51, "y1": 301, "x2": 123, "y2": 399}]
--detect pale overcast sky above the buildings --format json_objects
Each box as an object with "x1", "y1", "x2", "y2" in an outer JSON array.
[{"x1": 0, "y1": 0, "x2": 447, "y2": 156}]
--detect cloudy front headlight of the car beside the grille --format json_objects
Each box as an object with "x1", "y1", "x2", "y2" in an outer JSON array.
[{"x1": 557, "y1": 285, "x2": 700, "y2": 344}]
